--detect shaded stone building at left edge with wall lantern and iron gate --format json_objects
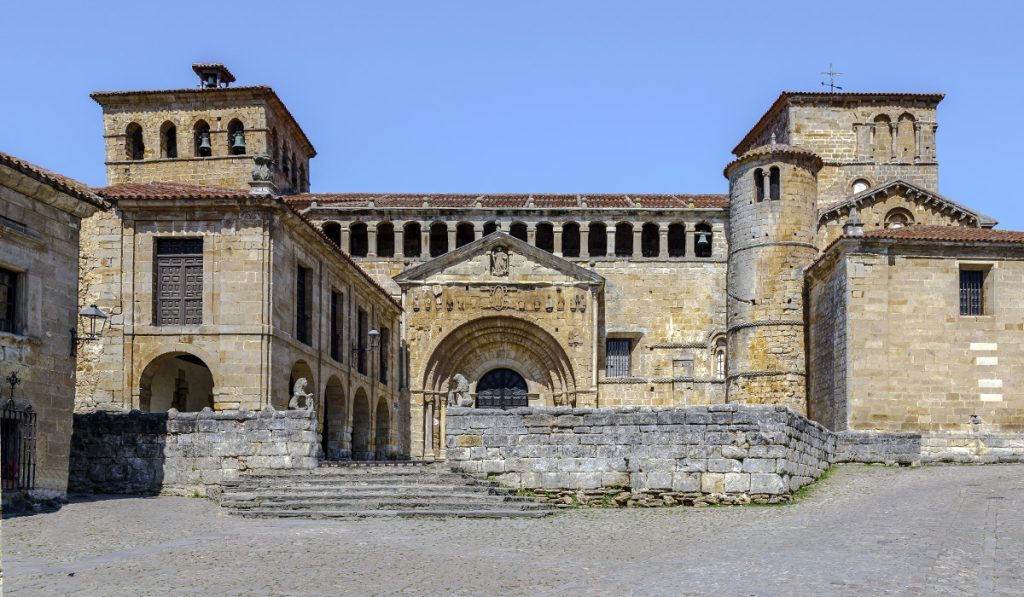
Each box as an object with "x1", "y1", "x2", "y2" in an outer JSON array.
[{"x1": 0, "y1": 154, "x2": 104, "y2": 503}]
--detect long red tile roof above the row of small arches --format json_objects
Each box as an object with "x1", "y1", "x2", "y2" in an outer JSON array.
[{"x1": 285, "y1": 193, "x2": 729, "y2": 209}]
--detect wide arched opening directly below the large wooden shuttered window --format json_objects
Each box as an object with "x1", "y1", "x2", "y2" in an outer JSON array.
[{"x1": 138, "y1": 352, "x2": 213, "y2": 413}]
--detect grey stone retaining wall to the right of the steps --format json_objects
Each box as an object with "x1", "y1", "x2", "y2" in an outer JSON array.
[{"x1": 446, "y1": 404, "x2": 836, "y2": 505}]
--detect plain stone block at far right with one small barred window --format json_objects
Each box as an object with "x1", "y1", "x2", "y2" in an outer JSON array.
[{"x1": 808, "y1": 235, "x2": 1024, "y2": 447}]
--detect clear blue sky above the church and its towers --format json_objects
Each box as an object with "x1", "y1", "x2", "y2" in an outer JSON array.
[{"x1": 0, "y1": 0, "x2": 1024, "y2": 229}]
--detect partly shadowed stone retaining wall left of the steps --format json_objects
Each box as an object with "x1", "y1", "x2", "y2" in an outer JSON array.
[{"x1": 69, "y1": 409, "x2": 318, "y2": 496}]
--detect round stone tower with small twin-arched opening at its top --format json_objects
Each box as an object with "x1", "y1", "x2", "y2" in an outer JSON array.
[{"x1": 725, "y1": 136, "x2": 821, "y2": 414}]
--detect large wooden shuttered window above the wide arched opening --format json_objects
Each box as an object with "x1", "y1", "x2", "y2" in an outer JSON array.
[{"x1": 154, "y1": 239, "x2": 203, "y2": 326}]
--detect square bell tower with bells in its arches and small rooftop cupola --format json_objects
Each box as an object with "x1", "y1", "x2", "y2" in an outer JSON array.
[{"x1": 90, "y1": 63, "x2": 316, "y2": 194}]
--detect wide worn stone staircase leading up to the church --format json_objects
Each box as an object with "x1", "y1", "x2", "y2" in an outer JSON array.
[{"x1": 220, "y1": 461, "x2": 552, "y2": 518}]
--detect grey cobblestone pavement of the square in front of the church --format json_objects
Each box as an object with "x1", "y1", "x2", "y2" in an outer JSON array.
[{"x1": 3, "y1": 465, "x2": 1024, "y2": 596}]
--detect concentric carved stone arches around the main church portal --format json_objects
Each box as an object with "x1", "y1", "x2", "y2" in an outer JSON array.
[{"x1": 415, "y1": 316, "x2": 577, "y2": 406}]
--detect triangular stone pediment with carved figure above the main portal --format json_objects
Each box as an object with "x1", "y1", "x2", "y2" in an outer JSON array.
[{"x1": 394, "y1": 232, "x2": 604, "y2": 287}]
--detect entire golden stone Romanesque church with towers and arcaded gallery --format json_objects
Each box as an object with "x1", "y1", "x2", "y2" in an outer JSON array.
[{"x1": 77, "y1": 65, "x2": 1024, "y2": 459}]
